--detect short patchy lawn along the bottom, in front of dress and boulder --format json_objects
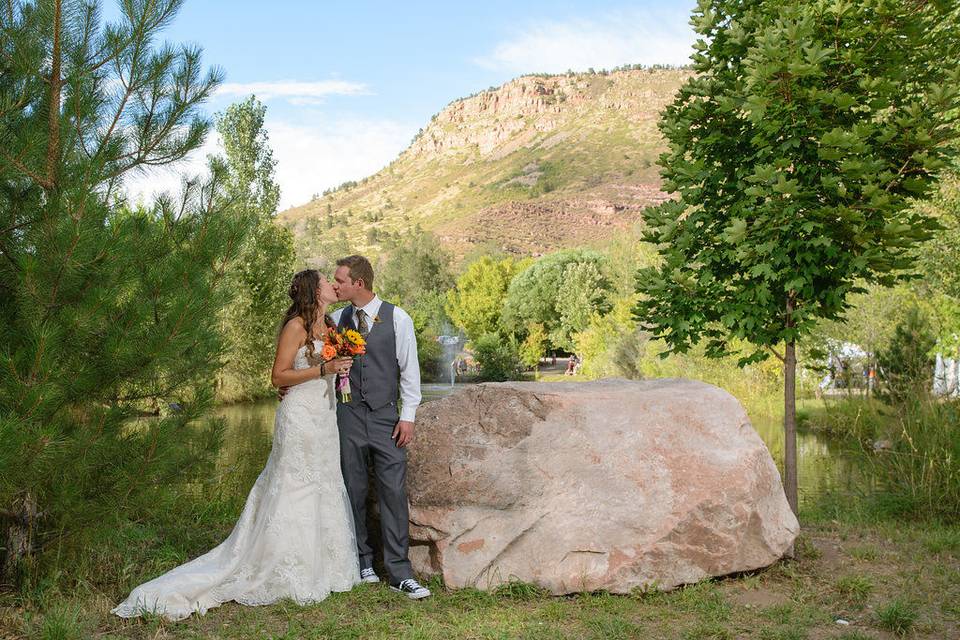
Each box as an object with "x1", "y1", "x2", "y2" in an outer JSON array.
[{"x1": 0, "y1": 513, "x2": 960, "y2": 640}]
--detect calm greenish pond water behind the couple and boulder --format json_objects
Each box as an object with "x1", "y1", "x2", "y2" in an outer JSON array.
[{"x1": 218, "y1": 384, "x2": 863, "y2": 505}]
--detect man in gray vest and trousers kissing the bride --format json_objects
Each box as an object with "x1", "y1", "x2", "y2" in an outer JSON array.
[{"x1": 332, "y1": 256, "x2": 430, "y2": 600}]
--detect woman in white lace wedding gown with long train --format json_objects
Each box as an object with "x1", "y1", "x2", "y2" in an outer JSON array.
[{"x1": 113, "y1": 269, "x2": 360, "y2": 620}]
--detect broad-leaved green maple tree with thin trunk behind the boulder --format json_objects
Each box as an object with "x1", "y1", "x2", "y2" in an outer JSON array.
[{"x1": 636, "y1": 0, "x2": 960, "y2": 512}]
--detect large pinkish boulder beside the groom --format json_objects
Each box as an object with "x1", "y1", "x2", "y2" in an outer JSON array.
[{"x1": 407, "y1": 379, "x2": 799, "y2": 594}]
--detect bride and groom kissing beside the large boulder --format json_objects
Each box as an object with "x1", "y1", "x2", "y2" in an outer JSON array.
[{"x1": 113, "y1": 255, "x2": 430, "y2": 620}]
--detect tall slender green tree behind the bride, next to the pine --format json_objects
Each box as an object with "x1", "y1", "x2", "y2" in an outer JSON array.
[{"x1": 216, "y1": 96, "x2": 296, "y2": 401}]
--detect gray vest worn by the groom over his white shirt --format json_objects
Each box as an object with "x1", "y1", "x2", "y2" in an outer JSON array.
[{"x1": 338, "y1": 301, "x2": 400, "y2": 411}]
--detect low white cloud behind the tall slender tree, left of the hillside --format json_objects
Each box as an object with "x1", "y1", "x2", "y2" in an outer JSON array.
[{"x1": 115, "y1": 115, "x2": 416, "y2": 211}]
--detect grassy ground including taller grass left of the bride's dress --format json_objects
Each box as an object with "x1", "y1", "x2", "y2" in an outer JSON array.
[{"x1": 7, "y1": 396, "x2": 960, "y2": 640}]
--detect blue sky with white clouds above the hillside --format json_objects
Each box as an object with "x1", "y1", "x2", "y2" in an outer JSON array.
[{"x1": 114, "y1": 0, "x2": 694, "y2": 208}]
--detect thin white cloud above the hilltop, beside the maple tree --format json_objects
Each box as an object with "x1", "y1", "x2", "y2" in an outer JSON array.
[{"x1": 474, "y1": 10, "x2": 695, "y2": 74}]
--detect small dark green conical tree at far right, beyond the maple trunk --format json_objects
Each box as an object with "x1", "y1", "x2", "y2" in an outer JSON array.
[{"x1": 877, "y1": 306, "x2": 936, "y2": 403}]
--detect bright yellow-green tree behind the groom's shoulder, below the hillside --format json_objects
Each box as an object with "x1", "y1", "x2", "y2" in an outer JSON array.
[{"x1": 445, "y1": 255, "x2": 527, "y2": 340}]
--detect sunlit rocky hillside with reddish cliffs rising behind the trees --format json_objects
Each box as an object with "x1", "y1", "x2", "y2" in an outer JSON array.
[{"x1": 280, "y1": 69, "x2": 690, "y2": 257}]
